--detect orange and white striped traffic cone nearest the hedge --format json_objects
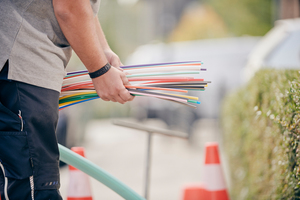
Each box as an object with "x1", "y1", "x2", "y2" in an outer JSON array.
[{"x1": 202, "y1": 142, "x2": 229, "y2": 200}]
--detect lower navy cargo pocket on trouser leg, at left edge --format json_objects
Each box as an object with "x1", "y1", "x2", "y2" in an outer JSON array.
[{"x1": 0, "y1": 131, "x2": 32, "y2": 179}]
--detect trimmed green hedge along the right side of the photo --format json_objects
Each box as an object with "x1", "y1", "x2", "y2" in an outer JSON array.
[{"x1": 222, "y1": 69, "x2": 300, "y2": 200}]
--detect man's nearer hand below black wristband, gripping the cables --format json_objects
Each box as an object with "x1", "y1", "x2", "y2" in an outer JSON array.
[{"x1": 92, "y1": 67, "x2": 134, "y2": 104}]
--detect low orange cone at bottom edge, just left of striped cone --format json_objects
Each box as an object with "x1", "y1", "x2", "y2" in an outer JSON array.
[{"x1": 183, "y1": 183, "x2": 207, "y2": 200}]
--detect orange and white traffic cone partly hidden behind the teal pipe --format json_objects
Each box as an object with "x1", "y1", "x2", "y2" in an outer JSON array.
[{"x1": 67, "y1": 147, "x2": 93, "y2": 200}]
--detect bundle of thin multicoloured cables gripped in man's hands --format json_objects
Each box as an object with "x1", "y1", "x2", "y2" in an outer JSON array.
[{"x1": 59, "y1": 61, "x2": 210, "y2": 110}]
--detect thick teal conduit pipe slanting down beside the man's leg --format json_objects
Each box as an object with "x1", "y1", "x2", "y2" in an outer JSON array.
[{"x1": 58, "y1": 144, "x2": 146, "y2": 200}]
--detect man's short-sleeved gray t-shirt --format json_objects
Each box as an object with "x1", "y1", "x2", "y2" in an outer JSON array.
[{"x1": 0, "y1": 0, "x2": 100, "y2": 92}]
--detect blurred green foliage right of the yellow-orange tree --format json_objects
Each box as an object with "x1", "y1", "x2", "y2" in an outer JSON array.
[{"x1": 205, "y1": 0, "x2": 277, "y2": 36}]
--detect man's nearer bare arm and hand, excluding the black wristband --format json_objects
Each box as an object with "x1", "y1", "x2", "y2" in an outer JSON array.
[{"x1": 53, "y1": 0, "x2": 133, "y2": 104}]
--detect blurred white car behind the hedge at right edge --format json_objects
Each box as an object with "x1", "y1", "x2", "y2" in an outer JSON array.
[{"x1": 244, "y1": 18, "x2": 300, "y2": 81}]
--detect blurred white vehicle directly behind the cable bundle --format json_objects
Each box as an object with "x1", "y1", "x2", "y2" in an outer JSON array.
[{"x1": 126, "y1": 37, "x2": 260, "y2": 132}]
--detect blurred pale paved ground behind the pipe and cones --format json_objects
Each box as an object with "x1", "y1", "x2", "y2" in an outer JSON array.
[{"x1": 61, "y1": 119, "x2": 229, "y2": 200}]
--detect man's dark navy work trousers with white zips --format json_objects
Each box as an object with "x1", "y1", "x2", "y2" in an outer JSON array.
[{"x1": 0, "y1": 63, "x2": 62, "y2": 200}]
